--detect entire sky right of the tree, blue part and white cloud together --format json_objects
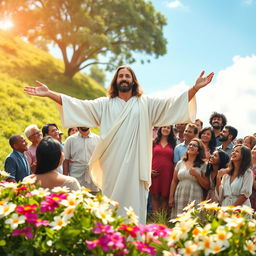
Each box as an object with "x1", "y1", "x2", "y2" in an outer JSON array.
[{"x1": 125, "y1": 0, "x2": 256, "y2": 137}]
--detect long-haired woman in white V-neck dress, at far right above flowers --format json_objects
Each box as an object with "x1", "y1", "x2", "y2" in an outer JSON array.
[{"x1": 215, "y1": 144, "x2": 253, "y2": 206}]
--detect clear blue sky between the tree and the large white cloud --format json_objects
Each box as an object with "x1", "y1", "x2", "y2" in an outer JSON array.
[{"x1": 129, "y1": 0, "x2": 256, "y2": 93}]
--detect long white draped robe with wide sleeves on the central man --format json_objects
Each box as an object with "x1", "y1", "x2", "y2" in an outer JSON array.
[{"x1": 60, "y1": 92, "x2": 196, "y2": 223}]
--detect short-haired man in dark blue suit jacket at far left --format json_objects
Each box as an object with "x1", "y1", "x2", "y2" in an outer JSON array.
[{"x1": 4, "y1": 134, "x2": 30, "y2": 182}]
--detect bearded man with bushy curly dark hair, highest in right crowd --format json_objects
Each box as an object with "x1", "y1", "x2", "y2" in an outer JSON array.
[{"x1": 209, "y1": 112, "x2": 227, "y2": 147}]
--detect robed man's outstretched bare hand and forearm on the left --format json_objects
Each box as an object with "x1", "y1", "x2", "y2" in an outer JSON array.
[{"x1": 24, "y1": 81, "x2": 62, "y2": 105}]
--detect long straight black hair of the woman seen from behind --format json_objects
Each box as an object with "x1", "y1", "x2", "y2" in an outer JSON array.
[{"x1": 35, "y1": 136, "x2": 62, "y2": 174}]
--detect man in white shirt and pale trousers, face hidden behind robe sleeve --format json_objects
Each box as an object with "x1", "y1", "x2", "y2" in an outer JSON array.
[{"x1": 63, "y1": 127, "x2": 100, "y2": 192}]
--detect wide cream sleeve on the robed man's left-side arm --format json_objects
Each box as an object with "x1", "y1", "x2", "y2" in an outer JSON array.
[{"x1": 58, "y1": 94, "x2": 108, "y2": 128}]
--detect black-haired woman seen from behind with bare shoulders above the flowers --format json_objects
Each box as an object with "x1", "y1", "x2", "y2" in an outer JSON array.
[{"x1": 24, "y1": 136, "x2": 81, "y2": 190}]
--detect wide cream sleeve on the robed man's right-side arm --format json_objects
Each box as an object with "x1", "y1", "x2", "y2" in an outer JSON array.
[{"x1": 149, "y1": 91, "x2": 196, "y2": 127}]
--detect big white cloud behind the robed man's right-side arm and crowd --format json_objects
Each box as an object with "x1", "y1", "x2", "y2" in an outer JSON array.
[{"x1": 151, "y1": 55, "x2": 256, "y2": 137}]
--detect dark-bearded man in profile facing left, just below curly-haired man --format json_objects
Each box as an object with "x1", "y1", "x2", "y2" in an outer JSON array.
[{"x1": 217, "y1": 125, "x2": 237, "y2": 156}]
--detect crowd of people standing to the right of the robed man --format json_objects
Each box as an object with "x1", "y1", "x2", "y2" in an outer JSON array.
[{"x1": 148, "y1": 112, "x2": 256, "y2": 218}]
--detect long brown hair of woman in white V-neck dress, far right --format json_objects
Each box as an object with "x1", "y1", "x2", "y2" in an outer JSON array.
[{"x1": 228, "y1": 144, "x2": 252, "y2": 177}]
